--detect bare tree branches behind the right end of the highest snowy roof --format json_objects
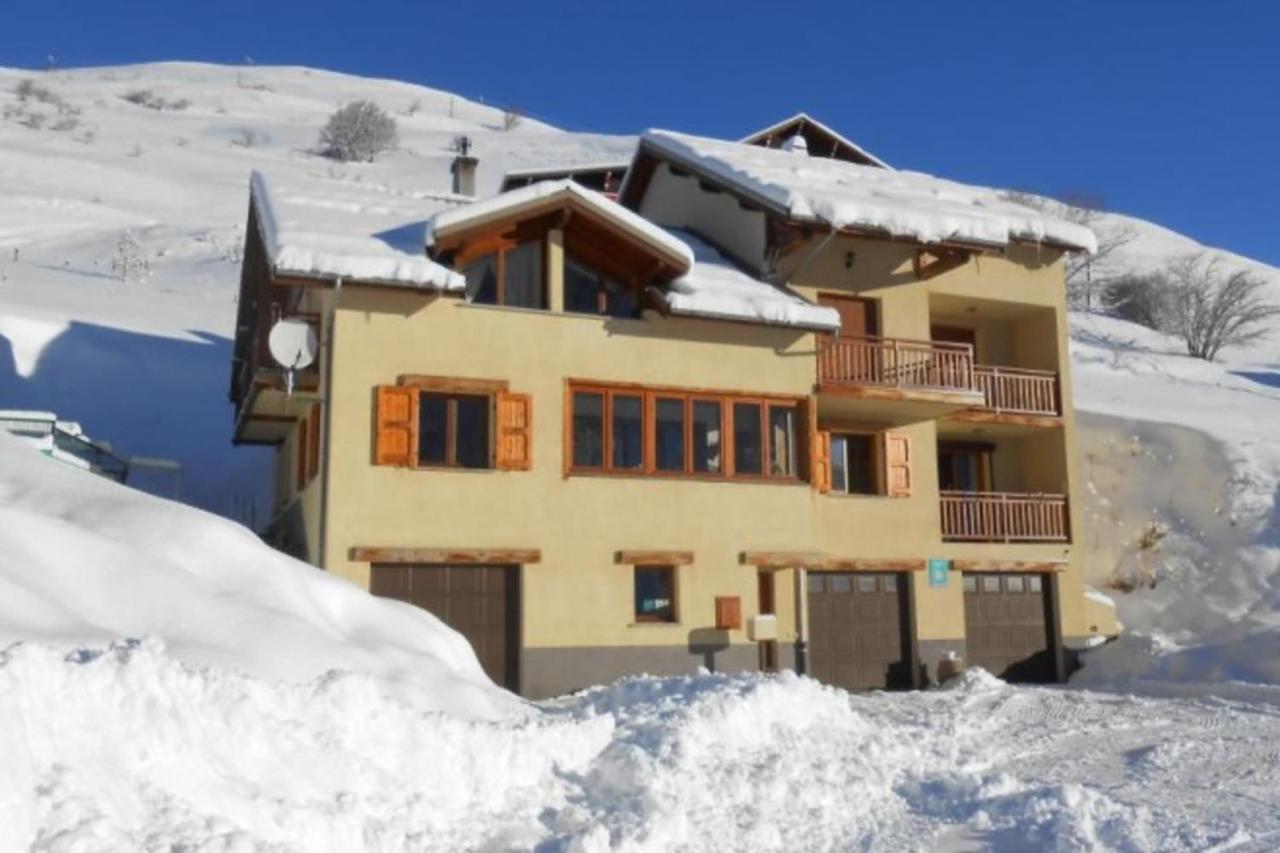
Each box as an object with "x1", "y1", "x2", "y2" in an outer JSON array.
[{"x1": 1005, "y1": 191, "x2": 1138, "y2": 311}]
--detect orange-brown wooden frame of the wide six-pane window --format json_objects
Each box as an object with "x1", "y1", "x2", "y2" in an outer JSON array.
[{"x1": 564, "y1": 379, "x2": 805, "y2": 483}]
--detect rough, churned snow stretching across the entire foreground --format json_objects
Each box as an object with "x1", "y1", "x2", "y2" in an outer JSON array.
[{"x1": 0, "y1": 642, "x2": 1280, "y2": 850}]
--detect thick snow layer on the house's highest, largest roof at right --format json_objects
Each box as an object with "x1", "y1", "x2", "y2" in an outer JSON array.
[{"x1": 634, "y1": 131, "x2": 1097, "y2": 254}]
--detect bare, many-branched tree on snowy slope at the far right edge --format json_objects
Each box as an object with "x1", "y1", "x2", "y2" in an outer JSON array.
[{"x1": 1165, "y1": 252, "x2": 1280, "y2": 361}]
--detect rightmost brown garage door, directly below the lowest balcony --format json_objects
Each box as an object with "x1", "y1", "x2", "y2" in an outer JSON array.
[{"x1": 964, "y1": 574, "x2": 1056, "y2": 681}]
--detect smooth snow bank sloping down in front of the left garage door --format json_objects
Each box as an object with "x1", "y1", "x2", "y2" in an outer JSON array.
[{"x1": 0, "y1": 434, "x2": 522, "y2": 719}]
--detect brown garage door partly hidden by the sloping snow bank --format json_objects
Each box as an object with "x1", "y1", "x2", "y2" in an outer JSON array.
[{"x1": 370, "y1": 565, "x2": 520, "y2": 690}]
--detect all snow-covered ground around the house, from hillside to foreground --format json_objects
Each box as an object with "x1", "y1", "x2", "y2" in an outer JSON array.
[{"x1": 0, "y1": 64, "x2": 1280, "y2": 850}]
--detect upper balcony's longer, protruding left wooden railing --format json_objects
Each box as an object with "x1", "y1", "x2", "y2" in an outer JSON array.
[{"x1": 818, "y1": 337, "x2": 978, "y2": 391}]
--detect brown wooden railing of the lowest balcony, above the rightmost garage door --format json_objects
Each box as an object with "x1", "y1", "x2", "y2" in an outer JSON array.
[{"x1": 942, "y1": 492, "x2": 1070, "y2": 542}]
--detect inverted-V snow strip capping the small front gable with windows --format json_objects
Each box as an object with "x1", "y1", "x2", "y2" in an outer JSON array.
[{"x1": 426, "y1": 178, "x2": 694, "y2": 269}]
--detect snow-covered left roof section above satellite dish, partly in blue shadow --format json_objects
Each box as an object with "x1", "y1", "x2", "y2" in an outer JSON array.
[{"x1": 250, "y1": 172, "x2": 466, "y2": 291}]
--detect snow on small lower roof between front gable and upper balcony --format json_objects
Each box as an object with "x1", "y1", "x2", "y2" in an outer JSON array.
[{"x1": 655, "y1": 229, "x2": 840, "y2": 332}]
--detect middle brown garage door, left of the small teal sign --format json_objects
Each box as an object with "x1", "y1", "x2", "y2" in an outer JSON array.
[{"x1": 809, "y1": 571, "x2": 911, "y2": 690}]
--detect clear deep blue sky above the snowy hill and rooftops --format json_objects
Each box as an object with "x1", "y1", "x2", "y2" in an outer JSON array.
[{"x1": 10, "y1": 0, "x2": 1280, "y2": 264}]
